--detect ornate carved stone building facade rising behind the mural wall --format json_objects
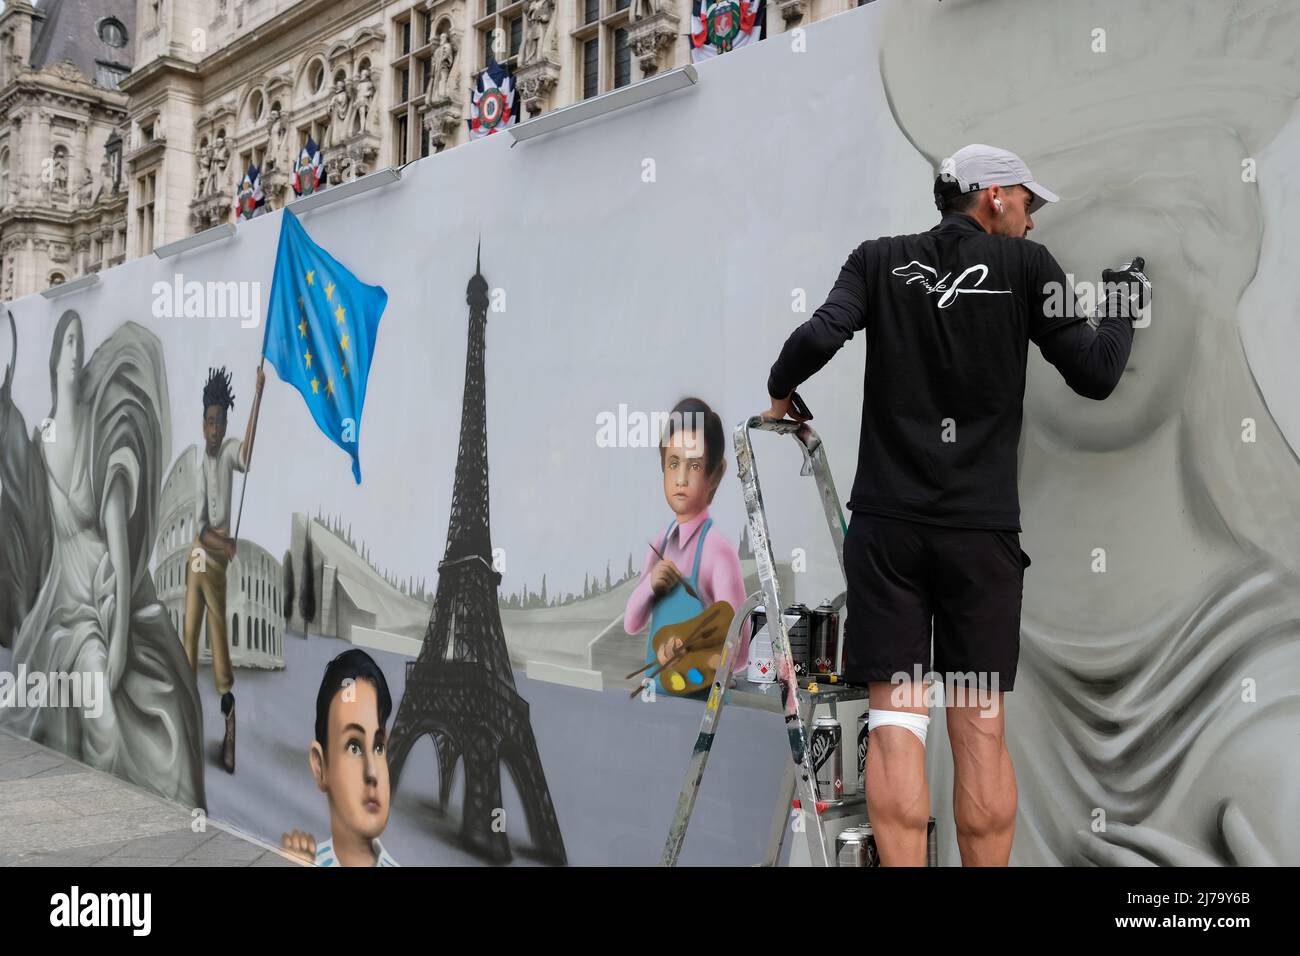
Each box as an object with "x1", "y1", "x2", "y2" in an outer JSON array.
[{"x1": 0, "y1": 0, "x2": 861, "y2": 294}]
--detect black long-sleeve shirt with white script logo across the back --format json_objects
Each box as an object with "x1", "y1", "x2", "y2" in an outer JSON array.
[{"x1": 767, "y1": 213, "x2": 1132, "y2": 531}]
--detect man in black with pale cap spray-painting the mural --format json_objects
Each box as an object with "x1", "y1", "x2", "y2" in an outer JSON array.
[{"x1": 764, "y1": 143, "x2": 1151, "y2": 866}]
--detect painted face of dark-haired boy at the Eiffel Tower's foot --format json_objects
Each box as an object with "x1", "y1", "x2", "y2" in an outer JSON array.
[{"x1": 315, "y1": 680, "x2": 390, "y2": 840}]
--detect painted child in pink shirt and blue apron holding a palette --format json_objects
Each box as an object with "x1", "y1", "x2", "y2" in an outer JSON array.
[{"x1": 623, "y1": 398, "x2": 749, "y2": 691}]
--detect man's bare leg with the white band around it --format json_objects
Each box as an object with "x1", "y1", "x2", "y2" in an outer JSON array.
[{"x1": 867, "y1": 680, "x2": 930, "y2": 866}]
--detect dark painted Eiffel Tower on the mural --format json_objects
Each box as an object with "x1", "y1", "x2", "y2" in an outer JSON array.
[{"x1": 389, "y1": 245, "x2": 567, "y2": 864}]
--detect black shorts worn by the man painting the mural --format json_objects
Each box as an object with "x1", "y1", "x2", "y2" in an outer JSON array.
[{"x1": 844, "y1": 511, "x2": 1030, "y2": 691}]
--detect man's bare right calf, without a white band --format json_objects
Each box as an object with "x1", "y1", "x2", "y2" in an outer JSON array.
[{"x1": 946, "y1": 693, "x2": 1017, "y2": 866}]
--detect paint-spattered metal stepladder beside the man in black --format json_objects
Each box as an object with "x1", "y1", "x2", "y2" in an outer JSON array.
[{"x1": 660, "y1": 416, "x2": 866, "y2": 866}]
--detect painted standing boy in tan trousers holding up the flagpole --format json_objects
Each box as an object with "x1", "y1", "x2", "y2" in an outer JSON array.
[{"x1": 185, "y1": 367, "x2": 267, "y2": 774}]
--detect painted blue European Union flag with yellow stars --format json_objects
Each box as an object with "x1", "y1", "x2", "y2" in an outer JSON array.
[{"x1": 263, "y1": 209, "x2": 389, "y2": 484}]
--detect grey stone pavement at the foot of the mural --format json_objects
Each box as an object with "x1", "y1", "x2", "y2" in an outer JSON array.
[{"x1": 0, "y1": 731, "x2": 300, "y2": 866}]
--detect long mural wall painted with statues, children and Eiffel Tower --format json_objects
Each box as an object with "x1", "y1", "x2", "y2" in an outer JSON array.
[{"x1": 0, "y1": 0, "x2": 1300, "y2": 865}]
